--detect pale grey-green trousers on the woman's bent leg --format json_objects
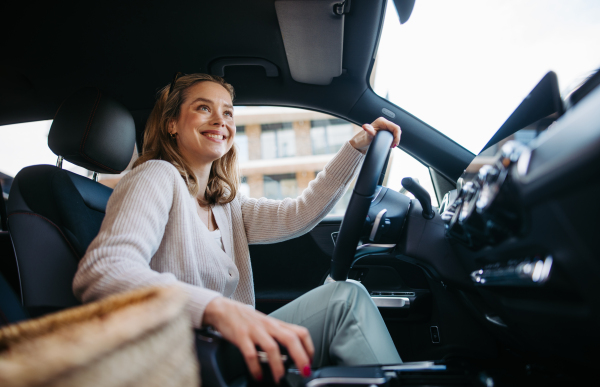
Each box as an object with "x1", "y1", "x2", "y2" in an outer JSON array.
[{"x1": 270, "y1": 281, "x2": 402, "y2": 367}]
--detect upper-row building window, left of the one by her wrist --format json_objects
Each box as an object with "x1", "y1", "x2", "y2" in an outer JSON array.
[{"x1": 260, "y1": 122, "x2": 296, "y2": 159}]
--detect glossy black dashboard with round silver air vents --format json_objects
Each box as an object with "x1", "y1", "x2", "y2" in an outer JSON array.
[{"x1": 428, "y1": 71, "x2": 600, "y2": 362}]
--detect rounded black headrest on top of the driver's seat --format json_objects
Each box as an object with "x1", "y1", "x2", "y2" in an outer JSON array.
[{"x1": 48, "y1": 87, "x2": 135, "y2": 173}]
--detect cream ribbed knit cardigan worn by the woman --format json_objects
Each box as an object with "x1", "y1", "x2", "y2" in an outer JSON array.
[{"x1": 73, "y1": 143, "x2": 363, "y2": 327}]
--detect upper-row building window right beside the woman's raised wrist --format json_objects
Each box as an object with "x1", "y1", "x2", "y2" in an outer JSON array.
[{"x1": 310, "y1": 118, "x2": 354, "y2": 155}]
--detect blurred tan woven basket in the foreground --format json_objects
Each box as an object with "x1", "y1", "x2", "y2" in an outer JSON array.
[{"x1": 0, "y1": 286, "x2": 200, "y2": 387}]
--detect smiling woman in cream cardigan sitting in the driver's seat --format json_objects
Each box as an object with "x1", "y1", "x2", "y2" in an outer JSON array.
[{"x1": 73, "y1": 74, "x2": 401, "y2": 380}]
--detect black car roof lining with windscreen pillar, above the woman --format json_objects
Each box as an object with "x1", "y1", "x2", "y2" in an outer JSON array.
[{"x1": 0, "y1": 0, "x2": 468, "y2": 176}]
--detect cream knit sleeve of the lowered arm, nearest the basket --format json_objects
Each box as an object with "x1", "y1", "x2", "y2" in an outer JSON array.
[{"x1": 73, "y1": 161, "x2": 221, "y2": 327}]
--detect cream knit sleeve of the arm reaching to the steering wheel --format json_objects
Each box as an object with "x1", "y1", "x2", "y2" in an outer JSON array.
[{"x1": 240, "y1": 142, "x2": 364, "y2": 244}]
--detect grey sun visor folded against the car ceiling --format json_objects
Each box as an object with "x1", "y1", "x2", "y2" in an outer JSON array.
[{"x1": 275, "y1": 0, "x2": 350, "y2": 85}]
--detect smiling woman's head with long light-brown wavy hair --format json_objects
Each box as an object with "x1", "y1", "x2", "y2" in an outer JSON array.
[{"x1": 134, "y1": 74, "x2": 239, "y2": 209}]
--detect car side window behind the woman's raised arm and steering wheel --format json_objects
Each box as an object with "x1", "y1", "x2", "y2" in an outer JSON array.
[{"x1": 235, "y1": 106, "x2": 437, "y2": 215}]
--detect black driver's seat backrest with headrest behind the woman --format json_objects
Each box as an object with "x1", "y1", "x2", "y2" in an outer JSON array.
[{"x1": 7, "y1": 88, "x2": 135, "y2": 316}]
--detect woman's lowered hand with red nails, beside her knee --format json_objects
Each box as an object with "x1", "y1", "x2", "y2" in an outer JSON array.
[{"x1": 202, "y1": 297, "x2": 314, "y2": 382}]
